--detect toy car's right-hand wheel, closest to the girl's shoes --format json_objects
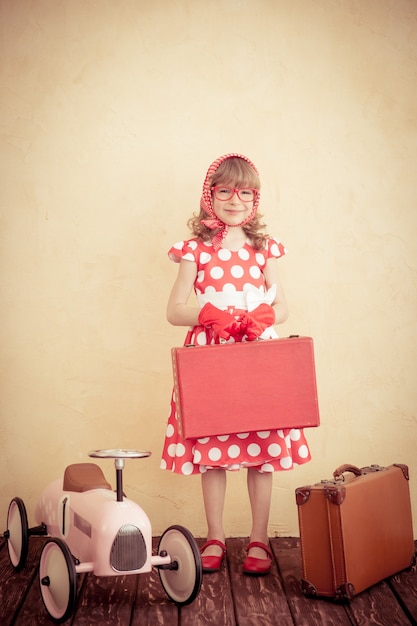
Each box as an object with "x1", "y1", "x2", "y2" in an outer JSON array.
[{"x1": 158, "y1": 526, "x2": 203, "y2": 605}]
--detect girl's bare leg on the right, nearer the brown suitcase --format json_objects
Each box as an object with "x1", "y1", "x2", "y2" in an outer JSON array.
[{"x1": 248, "y1": 468, "x2": 272, "y2": 559}]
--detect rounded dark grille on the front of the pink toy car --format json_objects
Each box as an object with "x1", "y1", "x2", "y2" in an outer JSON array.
[{"x1": 110, "y1": 524, "x2": 146, "y2": 572}]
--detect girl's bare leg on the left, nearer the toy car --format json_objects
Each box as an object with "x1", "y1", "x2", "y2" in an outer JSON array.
[{"x1": 201, "y1": 469, "x2": 226, "y2": 556}]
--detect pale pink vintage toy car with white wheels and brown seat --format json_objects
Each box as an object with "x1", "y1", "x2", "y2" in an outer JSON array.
[{"x1": 4, "y1": 449, "x2": 202, "y2": 622}]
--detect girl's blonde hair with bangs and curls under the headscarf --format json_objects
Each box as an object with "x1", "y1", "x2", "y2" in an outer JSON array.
[{"x1": 187, "y1": 157, "x2": 268, "y2": 250}]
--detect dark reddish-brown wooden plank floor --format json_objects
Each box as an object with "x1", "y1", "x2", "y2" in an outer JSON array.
[{"x1": 0, "y1": 537, "x2": 417, "y2": 626}]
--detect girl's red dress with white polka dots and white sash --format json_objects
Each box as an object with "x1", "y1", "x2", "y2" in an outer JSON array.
[{"x1": 161, "y1": 238, "x2": 311, "y2": 475}]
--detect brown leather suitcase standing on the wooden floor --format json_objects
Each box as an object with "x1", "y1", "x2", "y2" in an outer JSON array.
[{"x1": 296, "y1": 464, "x2": 415, "y2": 600}]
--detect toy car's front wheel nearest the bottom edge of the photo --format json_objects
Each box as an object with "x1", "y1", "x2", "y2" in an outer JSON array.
[{"x1": 39, "y1": 538, "x2": 77, "y2": 622}]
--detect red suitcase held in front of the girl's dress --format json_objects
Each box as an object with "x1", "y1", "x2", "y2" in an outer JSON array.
[{"x1": 172, "y1": 336, "x2": 319, "y2": 439}]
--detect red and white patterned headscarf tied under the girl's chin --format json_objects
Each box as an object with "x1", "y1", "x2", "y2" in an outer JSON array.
[{"x1": 200, "y1": 152, "x2": 260, "y2": 250}]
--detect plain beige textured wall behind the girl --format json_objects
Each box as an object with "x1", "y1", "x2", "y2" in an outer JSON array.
[{"x1": 0, "y1": 0, "x2": 417, "y2": 536}]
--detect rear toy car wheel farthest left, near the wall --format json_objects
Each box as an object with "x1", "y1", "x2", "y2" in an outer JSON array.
[{"x1": 4, "y1": 498, "x2": 29, "y2": 572}]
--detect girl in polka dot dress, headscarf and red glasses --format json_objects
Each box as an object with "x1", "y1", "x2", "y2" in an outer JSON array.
[{"x1": 161, "y1": 154, "x2": 310, "y2": 575}]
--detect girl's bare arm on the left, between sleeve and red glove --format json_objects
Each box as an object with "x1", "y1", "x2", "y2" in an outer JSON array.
[{"x1": 167, "y1": 260, "x2": 200, "y2": 326}]
